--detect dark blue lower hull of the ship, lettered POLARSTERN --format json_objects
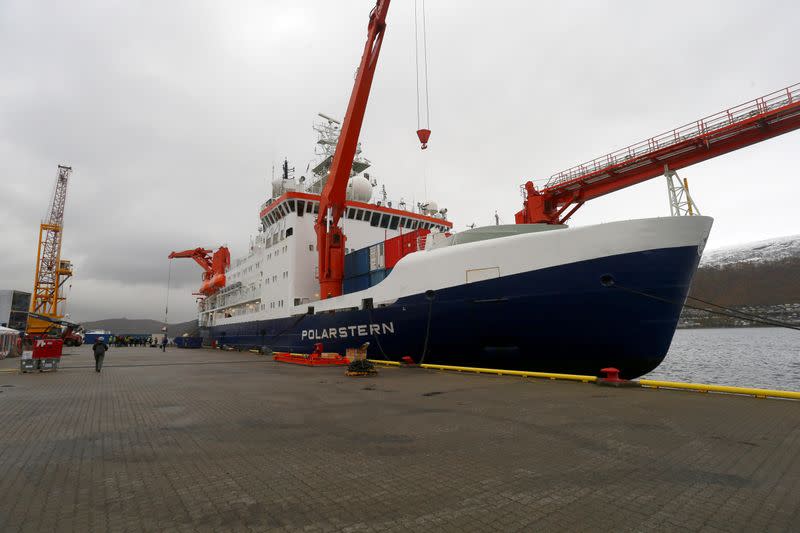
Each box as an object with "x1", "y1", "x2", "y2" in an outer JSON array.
[{"x1": 204, "y1": 246, "x2": 699, "y2": 378}]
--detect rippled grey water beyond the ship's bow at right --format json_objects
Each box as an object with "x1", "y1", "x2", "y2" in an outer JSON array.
[{"x1": 643, "y1": 328, "x2": 800, "y2": 391}]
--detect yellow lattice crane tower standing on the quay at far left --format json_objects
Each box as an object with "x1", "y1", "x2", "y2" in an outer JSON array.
[{"x1": 27, "y1": 165, "x2": 72, "y2": 335}]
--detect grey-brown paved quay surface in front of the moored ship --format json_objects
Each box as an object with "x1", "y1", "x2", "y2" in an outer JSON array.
[{"x1": 0, "y1": 347, "x2": 800, "y2": 532}]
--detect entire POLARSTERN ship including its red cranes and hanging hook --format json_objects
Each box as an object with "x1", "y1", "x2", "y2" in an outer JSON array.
[{"x1": 175, "y1": 0, "x2": 800, "y2": 378}]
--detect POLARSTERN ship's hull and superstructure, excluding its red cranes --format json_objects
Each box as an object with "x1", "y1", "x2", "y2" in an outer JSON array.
[{"x1": 189, "y1": 111, "x2": 711, "y2": 377}]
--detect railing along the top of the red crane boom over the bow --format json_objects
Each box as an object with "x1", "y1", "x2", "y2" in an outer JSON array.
[{"x1": 543, "y1": 83, "x2": 800, "y2": 191}]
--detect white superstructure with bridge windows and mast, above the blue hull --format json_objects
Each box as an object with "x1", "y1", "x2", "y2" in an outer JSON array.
[{"x1": 199, "y1": 115, "x2": 452, "y2": 327}]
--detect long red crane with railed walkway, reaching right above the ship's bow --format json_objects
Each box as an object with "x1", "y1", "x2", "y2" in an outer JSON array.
[{"x1": 515, "y1": 83, "x2": 800, "y2": 224}]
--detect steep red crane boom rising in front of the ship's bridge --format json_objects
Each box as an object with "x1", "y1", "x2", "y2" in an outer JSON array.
[{"x1": 315, "y1": 0, "x2": 390, "y2": 299}]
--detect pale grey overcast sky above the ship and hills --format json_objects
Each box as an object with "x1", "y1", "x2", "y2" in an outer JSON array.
[{"x1": 0, "y1": 0, "x2": 800, "y2": 322}]
